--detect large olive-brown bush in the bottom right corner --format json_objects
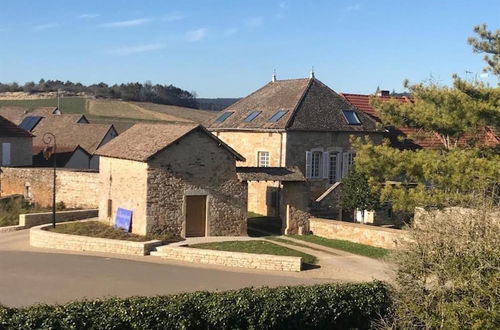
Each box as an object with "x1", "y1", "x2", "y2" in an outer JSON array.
[{"x1": 386, "y1": 196, "x2": 500, "y2": 329}]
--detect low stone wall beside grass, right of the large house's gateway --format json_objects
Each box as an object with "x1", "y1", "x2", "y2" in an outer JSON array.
[{"x1": 309, "y1": 218, "x2": 406, "y2": 249}]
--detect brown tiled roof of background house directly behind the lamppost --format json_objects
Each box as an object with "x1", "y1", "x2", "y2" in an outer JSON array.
[{"x1": 32, "y1": 115, "x2": 116, "y2": 154}]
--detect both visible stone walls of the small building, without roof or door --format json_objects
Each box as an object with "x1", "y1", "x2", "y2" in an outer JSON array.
[{"x1": 99, "y1": 131, "x2": 247, "y2": 237}]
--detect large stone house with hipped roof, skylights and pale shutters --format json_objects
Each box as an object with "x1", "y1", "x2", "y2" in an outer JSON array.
[{"x1": 208, "y1": 74, "x2": 383, "y2": 219}]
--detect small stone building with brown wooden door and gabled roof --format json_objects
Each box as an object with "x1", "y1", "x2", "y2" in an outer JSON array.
[{"x1": 97, "y1": 124, "x2": 247, "y2": 237}]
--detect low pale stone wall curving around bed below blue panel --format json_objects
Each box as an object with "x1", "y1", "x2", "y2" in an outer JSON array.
[{"x1": 30, "y1": 225, "x2": 162, "y2": 256}]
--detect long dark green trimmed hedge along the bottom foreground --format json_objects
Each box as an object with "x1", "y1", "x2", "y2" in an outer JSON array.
[{"x1": 0, "y1": 282, "x2": 389, "y2": 329}]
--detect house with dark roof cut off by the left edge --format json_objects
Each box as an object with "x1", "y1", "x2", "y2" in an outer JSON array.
[{"x1": 0, "y1": 116, "x2": 33, "y2": 166}]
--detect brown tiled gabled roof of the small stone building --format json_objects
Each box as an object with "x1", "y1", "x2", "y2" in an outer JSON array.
[{"x1": 97, "y1": 123, "x2": 245, "y2": 162}]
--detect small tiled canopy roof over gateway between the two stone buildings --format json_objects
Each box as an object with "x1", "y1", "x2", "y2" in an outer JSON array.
[{"x1": 236, "y1": 167, "x2": 306, "y2": 182}]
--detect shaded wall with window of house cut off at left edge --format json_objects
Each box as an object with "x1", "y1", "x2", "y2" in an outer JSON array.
[{"x1": 0, "y1": 137, "x2": 33, "y2": 166}]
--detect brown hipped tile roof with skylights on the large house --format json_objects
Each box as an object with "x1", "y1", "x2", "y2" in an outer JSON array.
[{"x1": 209, "y1": 78, "x2": 376, "y2": 132}]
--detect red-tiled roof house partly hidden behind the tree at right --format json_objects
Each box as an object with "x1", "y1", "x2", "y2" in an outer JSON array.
[{"x1": 341, "y1": 91, "x2": 500, "y2": 149}]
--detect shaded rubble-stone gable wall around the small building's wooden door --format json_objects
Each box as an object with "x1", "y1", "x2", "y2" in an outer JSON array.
[{"x1": 147, "y1": 131, "x2": 247, "y2": 237}]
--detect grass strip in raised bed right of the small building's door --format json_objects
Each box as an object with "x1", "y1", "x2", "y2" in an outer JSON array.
[{"x1": 189, "y1": 240, "x2": 318, "y2": 265}]
